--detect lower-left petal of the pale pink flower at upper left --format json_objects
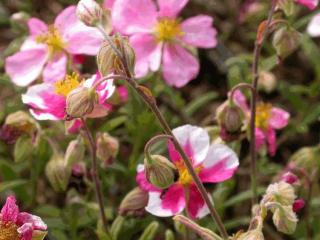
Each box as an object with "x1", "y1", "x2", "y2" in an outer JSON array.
[{"x1": 5, "y1": 49, "x2": 47, "y2": 87}]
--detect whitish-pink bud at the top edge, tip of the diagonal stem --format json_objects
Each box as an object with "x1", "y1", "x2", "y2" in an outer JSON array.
[{"x1": 76, "y1": 0, "x2": 103, "y2": 27}]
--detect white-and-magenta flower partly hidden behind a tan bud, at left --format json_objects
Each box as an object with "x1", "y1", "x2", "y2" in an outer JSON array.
[{"x1": 22, "y1": 71, "x2": 115, "y2": 120}]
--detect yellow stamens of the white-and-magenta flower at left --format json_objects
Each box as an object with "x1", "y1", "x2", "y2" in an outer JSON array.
[{"x1": 54, "y1": 73, "x2": 81, "y2": 97}]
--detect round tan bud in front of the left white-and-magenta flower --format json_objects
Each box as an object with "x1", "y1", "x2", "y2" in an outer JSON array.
[{"x1": 66, "y1": 87, "x2": 98, "y2": 118}]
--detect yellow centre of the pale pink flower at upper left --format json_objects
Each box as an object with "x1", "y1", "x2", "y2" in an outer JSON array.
[{"x1": 36, "y1": 25, "x2": 66, "y2": 55}]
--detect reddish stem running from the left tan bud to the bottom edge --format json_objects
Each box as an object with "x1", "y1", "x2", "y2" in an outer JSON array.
[{"x1": 81, "y1": 118, "x2": 112, "y2": 239}]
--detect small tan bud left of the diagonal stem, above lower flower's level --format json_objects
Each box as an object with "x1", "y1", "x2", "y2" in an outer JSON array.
[{"x1": 97, "y1": 133, "x2": 119, "y2": 162}]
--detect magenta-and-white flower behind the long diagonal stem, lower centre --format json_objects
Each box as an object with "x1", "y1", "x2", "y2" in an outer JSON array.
[{"x1": 136, "y1": 125, "x2": 239, "y2": 218}]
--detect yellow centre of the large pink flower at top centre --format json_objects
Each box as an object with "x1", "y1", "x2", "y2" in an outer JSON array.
[{"x1": 155, "y1": 18, "x2": 184, "y2": 42}]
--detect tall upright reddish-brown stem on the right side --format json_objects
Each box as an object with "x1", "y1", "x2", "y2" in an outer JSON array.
[{"x1": 250, "y1": 0, "x2": 277, "y2": 205}]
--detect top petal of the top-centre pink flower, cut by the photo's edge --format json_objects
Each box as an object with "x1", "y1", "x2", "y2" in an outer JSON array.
[{"x1": 157, "y1": 0, "x2": 189, "y2": 18}]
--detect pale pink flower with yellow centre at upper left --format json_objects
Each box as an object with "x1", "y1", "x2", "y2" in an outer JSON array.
[{"x1": 5, "y1": 6, "x2": 103, "y2": 86}]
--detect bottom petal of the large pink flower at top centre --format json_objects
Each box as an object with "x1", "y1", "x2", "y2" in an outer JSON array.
[{"x1": 162, "y1": 44, "x2": 200, "y2": 87}]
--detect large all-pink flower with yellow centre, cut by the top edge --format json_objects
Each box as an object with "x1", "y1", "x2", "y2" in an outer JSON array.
[{"x1": 112, "y1": 0, "x2": 217, "y2": 87}]
